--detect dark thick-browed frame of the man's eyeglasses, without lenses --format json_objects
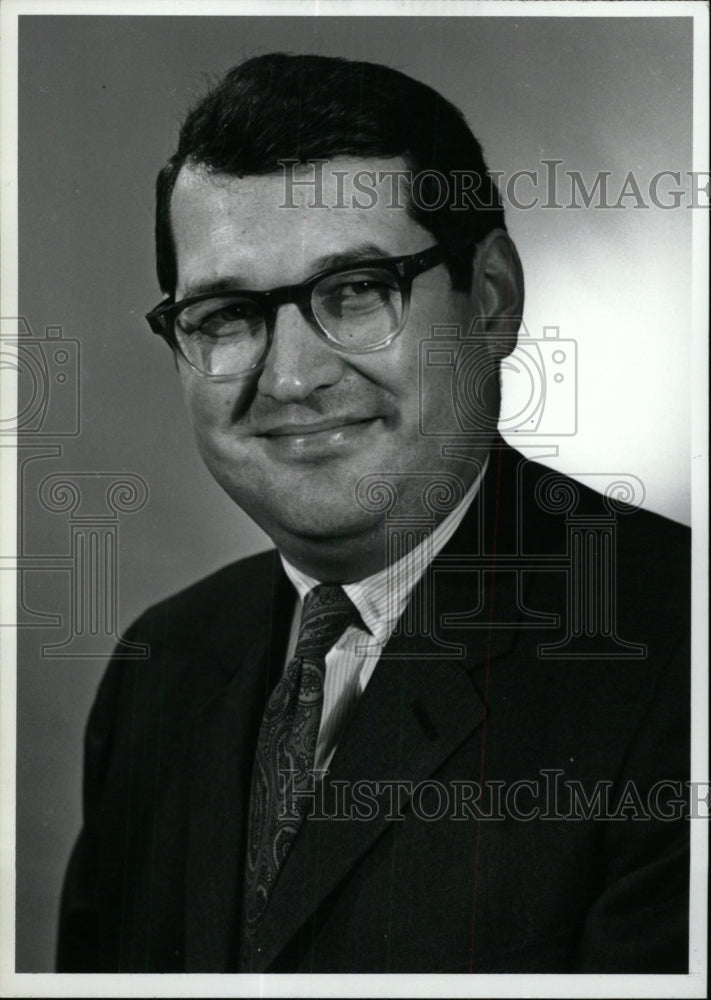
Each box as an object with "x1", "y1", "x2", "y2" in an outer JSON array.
[{"x1": 146, "y1": 243, "x2": 464, "y2": 382}]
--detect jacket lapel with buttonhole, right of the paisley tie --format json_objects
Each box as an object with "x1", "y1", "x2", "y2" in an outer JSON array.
[{"x1": 255, "y1": 640, "x2": 484, "y2": 970}]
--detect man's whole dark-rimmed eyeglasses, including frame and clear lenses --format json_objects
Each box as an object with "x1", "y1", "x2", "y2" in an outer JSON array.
[{"x1": 146, "y1": 244, "x2": 444, "y2": 381}]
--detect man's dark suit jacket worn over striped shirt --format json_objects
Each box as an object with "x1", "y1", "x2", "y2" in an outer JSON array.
[{"x1": 58, "y1": 444, "x2": 690, "y2": 972}]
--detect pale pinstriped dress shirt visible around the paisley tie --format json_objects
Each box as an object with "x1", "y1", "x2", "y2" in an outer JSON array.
[{"x1": 281, "y1": 457, "x2": 489, "y2": 771}]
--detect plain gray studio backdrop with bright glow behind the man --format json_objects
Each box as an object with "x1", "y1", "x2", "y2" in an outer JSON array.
[{"x1": 17, "y1": 16, "x2": 693, "y2": 971}]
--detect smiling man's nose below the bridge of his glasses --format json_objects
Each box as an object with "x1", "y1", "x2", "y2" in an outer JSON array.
[{"x1": 257, "y1": 303, "x2": 345, "y2": 403}]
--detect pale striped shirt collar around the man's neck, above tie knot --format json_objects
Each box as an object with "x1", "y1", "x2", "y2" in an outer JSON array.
[{"x1": 280, "y1": 455, "x2": 489, "y2": 645}]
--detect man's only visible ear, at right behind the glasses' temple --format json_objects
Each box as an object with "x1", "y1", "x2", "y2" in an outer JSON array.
[{"x1": 471, "y1": 229, "x2": 524, "y2": 358}]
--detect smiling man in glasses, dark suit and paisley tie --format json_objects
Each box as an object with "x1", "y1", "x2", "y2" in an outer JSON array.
[{"x1": 58, "y1": 55, "x2": 689, "y2": 972}]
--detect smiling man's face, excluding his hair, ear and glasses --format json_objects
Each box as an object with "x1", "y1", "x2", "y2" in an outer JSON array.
[{"x1": 171, "y1": 159, "x2": 500, "y2": 576}]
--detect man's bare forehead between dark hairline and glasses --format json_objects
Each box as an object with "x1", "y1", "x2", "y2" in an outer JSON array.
[{"x1": 171, "y1": 157, "x2": 434, "y2": 294}]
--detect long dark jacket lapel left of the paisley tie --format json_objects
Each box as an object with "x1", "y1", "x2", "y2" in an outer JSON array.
[{"x1": 186, "y1": 554, "x2": 293, "y2": 972}]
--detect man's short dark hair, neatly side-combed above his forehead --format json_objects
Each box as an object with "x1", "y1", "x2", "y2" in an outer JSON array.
[{"x1": 156, "y1": 53, "x2": 505, "y2": 295}]
